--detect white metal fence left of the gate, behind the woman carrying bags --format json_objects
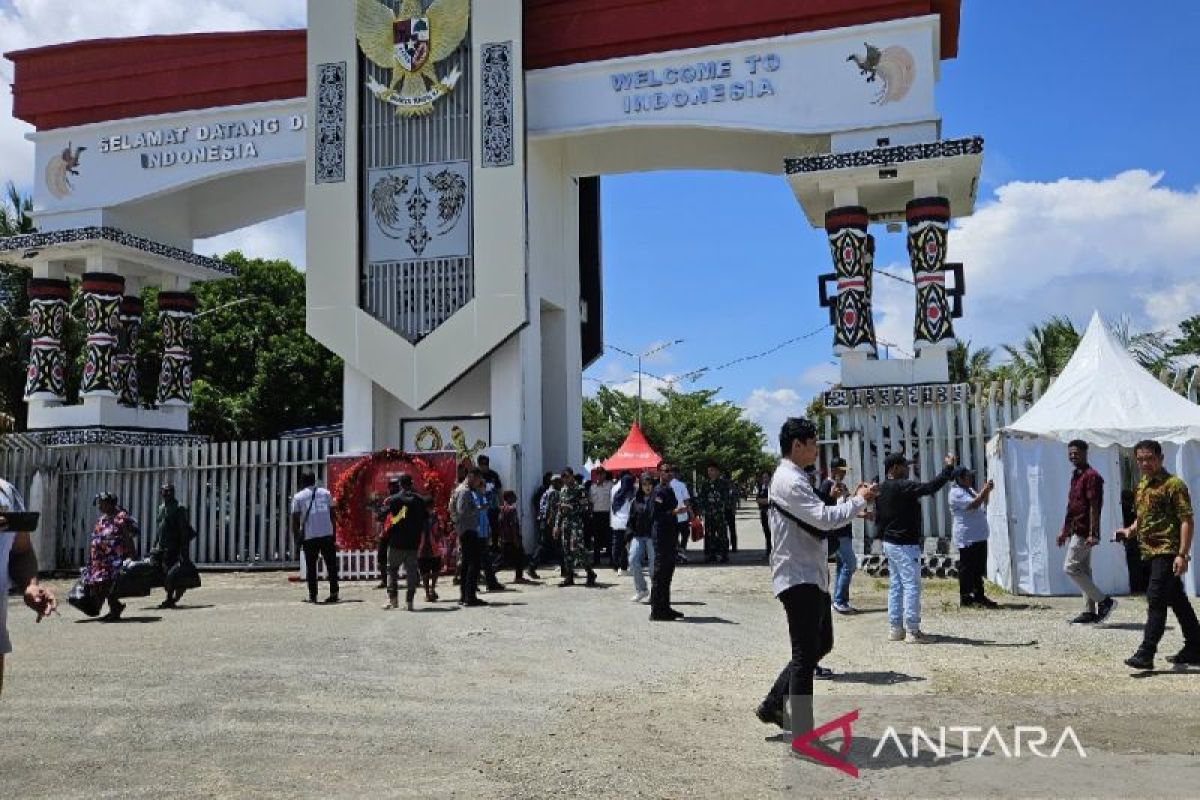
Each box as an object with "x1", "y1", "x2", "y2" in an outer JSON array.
[{"x1": 0, "y1": 435, "x2": 342, "y2": 567}]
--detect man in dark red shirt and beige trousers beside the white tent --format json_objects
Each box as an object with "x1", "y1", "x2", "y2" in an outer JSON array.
[{"x1": 1058, "y1": 439, "x2": 1117, "y2": 624}]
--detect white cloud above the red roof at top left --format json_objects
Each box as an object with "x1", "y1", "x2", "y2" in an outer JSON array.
[{"x1": 0, "y1": 0, "x2": 306, "y2": 187}]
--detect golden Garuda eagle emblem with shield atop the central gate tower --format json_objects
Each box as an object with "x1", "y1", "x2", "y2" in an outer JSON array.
[{"x1": 354, "y1": 0, "x2": 470, "y2": 116}]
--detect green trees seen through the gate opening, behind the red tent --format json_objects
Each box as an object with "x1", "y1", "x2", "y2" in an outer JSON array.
[{"x1": 583, "y1": 386, "x2": 767, "y2": 480}]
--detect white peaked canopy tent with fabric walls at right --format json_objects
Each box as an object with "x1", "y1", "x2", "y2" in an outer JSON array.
[{"x1": 988, "y1": 314, "x2": 1200, "y2": 595}]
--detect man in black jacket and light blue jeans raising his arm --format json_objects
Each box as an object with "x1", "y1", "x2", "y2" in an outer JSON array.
[{"x1": 875, "y1": 453, "x2": 955, "y2": 644}]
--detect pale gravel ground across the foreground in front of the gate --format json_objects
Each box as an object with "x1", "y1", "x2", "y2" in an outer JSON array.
[{"x1": 0, "y1": 516, "x2": 1200, "y2": 799}]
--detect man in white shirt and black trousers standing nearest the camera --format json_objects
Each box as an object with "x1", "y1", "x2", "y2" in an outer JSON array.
[{"x1": 756, "y1": 417, "x2": 876, "y2": 734}]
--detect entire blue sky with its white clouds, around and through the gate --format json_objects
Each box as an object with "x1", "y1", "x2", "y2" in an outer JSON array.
[{"x1": 0, "y1": 0, "x2": 1200, "y2": 438}]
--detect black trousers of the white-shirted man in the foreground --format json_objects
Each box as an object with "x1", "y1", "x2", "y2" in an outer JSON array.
[{"x1": 763, "y1": 583, "x2": 833, "y2": 733}]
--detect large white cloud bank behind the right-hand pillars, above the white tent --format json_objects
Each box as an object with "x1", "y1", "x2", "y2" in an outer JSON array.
[{"x1": 945, "y1": 169, "x2": 1200, "y2": 345}]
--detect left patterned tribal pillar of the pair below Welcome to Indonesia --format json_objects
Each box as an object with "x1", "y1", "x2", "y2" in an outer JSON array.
[{"x1": 826, "y1": 205, "x2": 875, "y2": 355}]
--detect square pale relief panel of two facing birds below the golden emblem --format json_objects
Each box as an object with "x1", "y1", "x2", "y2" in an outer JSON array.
[{"x1": 367, "y1": 161, "x2": 470, "y2": 263}]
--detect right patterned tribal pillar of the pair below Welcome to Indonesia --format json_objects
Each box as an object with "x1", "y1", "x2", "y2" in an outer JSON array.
[{"x1": 906, "y1": 197, "x2": 954, "y2": 353}]
